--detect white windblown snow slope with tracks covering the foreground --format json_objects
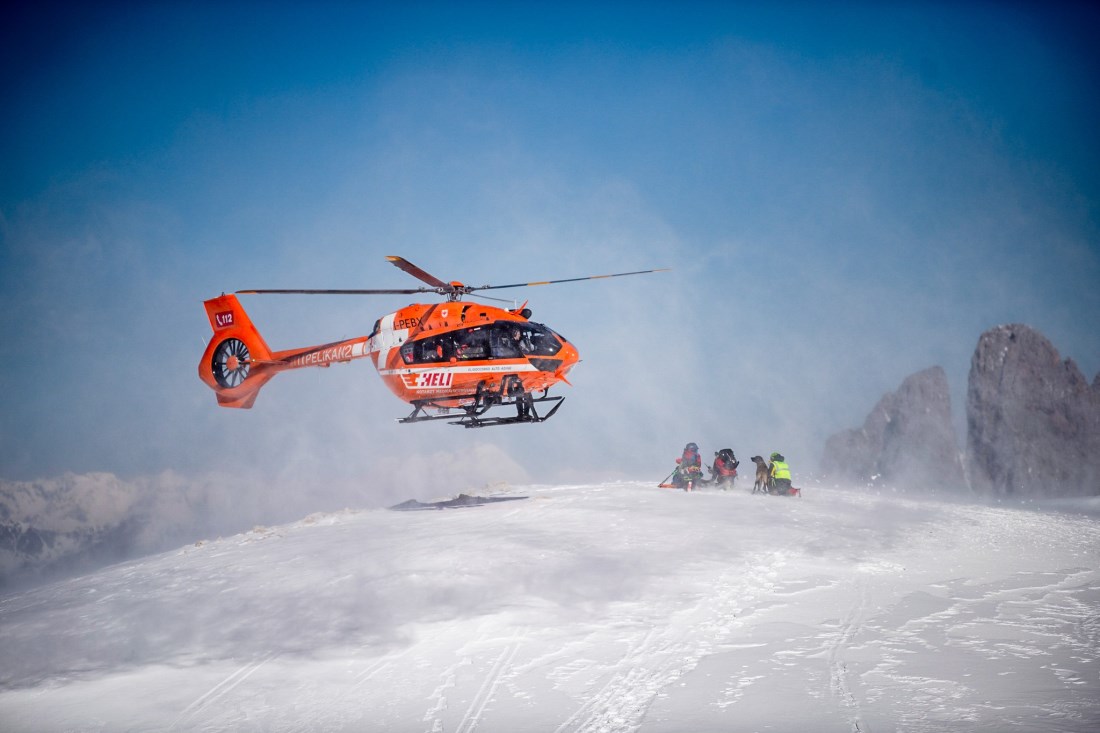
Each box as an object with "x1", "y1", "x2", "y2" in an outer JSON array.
[{"x1": 0, "y1": 483, "x2": 1100, "y2": 733}]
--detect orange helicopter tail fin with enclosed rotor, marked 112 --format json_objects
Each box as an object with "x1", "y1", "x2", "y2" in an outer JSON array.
[{"x1": 199, "y1": 295, "x2": 275, "y2": 409}]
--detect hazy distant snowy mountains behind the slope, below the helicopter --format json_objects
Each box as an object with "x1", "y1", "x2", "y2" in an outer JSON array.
[{"x1": 0, "y1": 444, "x2": 529, "y2": 589}]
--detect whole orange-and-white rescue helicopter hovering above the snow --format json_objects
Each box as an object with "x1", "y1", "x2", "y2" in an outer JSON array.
[{"x1": 199, "y1": 256, "x2": 668, "y2": 428}]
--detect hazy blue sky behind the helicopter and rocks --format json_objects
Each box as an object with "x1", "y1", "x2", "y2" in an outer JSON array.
[{"x1": 0, "y1": 3, "x2": 1100, "y2": 502}]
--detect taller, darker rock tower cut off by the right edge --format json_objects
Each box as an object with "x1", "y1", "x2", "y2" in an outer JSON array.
[{"x1": 967, "y1": 324, "x2": 1100, "y2": 497}]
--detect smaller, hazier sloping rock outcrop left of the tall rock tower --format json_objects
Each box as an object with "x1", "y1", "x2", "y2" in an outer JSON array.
[{"x1": 821, "y1": 367, "x2": 966, "y2": 491}]
